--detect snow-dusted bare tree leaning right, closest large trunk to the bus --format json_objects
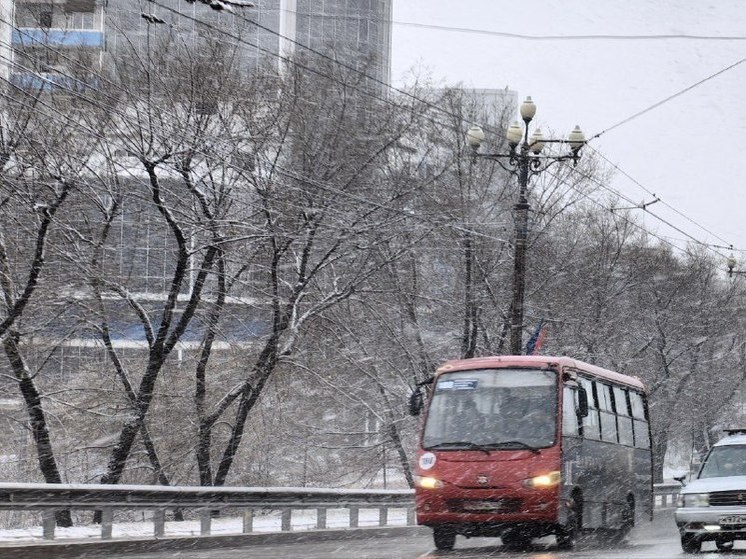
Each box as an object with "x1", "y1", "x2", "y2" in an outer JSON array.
[{"x1": 186, "y1": 54, "x2": 438, "y2": 485}]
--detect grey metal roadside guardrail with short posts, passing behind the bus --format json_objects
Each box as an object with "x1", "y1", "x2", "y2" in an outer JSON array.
[{"x1": 0, "y1": 483, "x2": 681, "y2": 540}]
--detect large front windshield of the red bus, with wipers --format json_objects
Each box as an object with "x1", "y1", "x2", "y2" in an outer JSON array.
[{"x1": 422, "y1": 369, "x2": 557, "y2": 450}]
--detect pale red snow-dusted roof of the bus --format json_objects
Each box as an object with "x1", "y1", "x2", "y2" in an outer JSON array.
[{"x1": 436, "y1": 355, "x2": 645, "y2": 392}]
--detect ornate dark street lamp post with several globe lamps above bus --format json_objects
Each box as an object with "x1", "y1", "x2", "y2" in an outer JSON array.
[{"x1": 466, "y1": 97, "x2": 585, "y2": 355}]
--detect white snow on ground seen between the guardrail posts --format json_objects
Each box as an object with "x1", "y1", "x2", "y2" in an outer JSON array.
[{"x1": 0, "y1": 509, "x2": 407, "y2": 546}]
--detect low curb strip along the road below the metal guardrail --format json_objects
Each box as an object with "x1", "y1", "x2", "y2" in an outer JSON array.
[{"x1": 0, "y1": 526, "x2": 430, "y2": 559}]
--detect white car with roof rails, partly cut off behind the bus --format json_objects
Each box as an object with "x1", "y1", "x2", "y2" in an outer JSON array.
[{"x1": 674, "y1": 429, "x2": 746, "y2": 553}]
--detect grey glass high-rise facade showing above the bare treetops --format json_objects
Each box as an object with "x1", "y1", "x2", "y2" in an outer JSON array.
[{"x1": 107, "y1": 0, "x2": 393, "y2": 83}]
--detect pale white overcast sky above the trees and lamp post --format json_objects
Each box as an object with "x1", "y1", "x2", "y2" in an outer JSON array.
[{"x1": 392, "y1": 0, "x2": 746, "y2": 269}]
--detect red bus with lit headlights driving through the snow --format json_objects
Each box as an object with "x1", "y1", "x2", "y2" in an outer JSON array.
[{"x1": 410, "y1": 356, "x2": 653, "y2": 549}]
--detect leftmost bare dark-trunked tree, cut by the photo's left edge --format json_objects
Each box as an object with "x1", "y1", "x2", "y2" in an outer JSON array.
[{"x1": 0, "y1": 91, "x2": 104, "y2": 526}]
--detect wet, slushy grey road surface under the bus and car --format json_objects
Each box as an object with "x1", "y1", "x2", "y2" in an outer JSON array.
[{"x1": 113, "y1": 512, "x2": 728, "y2": 559}]
